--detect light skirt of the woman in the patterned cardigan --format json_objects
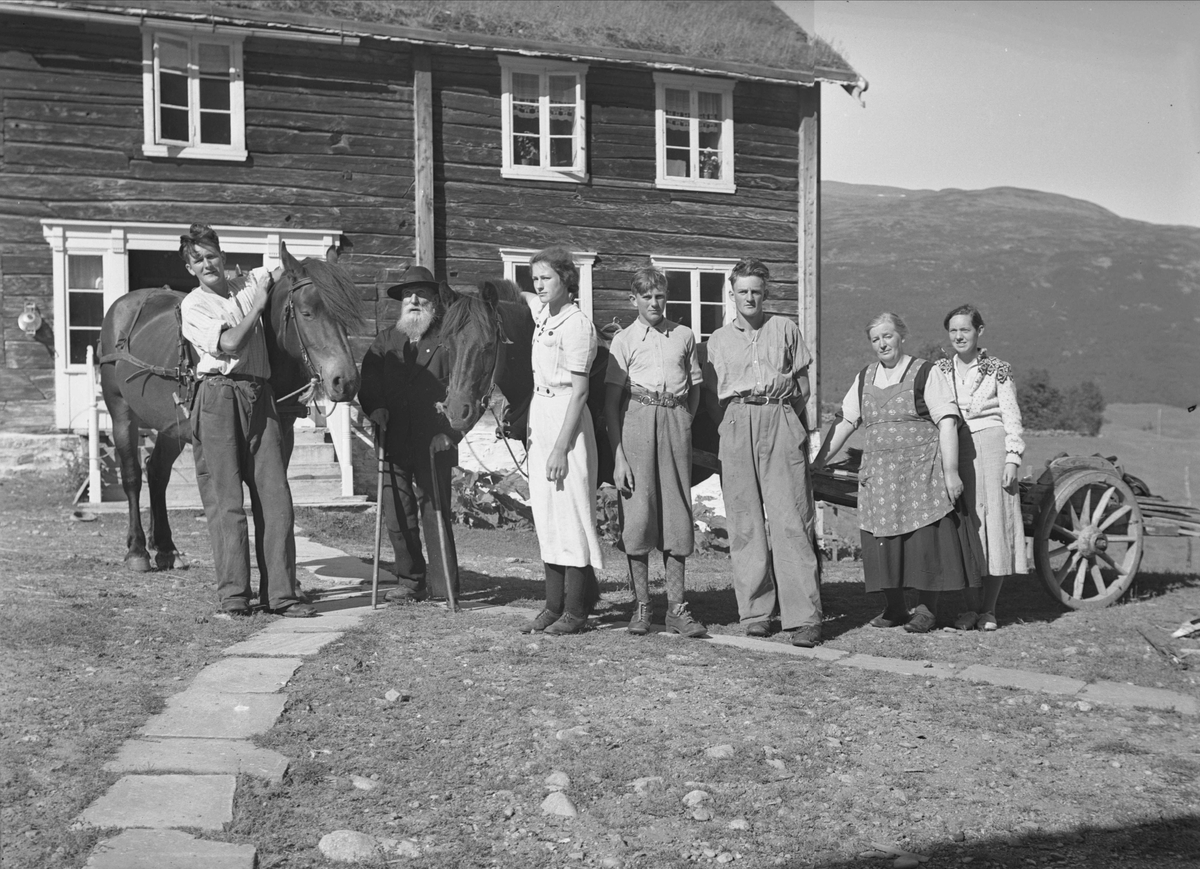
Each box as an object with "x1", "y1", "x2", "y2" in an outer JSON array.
[{"x1": 959, "y1": 426, "x2": 1028, "y2": 576}]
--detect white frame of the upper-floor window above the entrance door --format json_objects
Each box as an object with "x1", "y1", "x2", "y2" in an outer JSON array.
[{"x1": 142, "y1": 24, "x2": 248, "y2": 162}]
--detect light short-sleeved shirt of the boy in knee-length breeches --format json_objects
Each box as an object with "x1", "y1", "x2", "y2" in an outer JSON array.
[{"x1": 604, "y1": 319, "x2": 701, "y2": 396}]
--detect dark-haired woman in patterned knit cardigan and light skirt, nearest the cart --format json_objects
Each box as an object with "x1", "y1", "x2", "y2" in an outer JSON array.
[{"x1": 937, "y1": 305, "x2": 1027, "y2": 630}]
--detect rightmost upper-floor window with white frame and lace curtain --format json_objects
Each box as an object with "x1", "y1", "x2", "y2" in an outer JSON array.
[{"x1": 654, "y1": 72, "x2": 737, "y2": 193}]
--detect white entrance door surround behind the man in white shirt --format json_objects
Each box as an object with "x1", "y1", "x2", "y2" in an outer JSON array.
[{"x1": 42, "y1": 218, "x2": 341, "y2": 432}]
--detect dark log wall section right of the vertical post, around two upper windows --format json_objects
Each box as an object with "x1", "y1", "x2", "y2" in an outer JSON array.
[{"x1": 433, "y1": 52, "x2": 816, "y2": 333}]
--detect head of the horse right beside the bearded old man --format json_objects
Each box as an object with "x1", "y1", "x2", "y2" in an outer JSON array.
[{"x1": 438, "y1": 282, "x2": 509, "y2": 432}]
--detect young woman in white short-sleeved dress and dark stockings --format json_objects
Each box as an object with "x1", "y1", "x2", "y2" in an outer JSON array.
[{"x1": 523, "y1": 247, "x2": 604, "y2": 634}]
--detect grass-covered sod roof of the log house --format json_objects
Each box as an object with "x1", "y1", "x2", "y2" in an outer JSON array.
[{"x1": 213, "y1": 0, "x2": 853, "y2": 73}]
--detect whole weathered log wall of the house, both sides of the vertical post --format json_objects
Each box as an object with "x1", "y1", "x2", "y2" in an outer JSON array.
[{"x1": 0, "y1": 13, "x2": 817, "y2": 430}]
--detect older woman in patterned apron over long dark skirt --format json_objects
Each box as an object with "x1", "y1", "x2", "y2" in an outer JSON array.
[{"x1": 812, "y1": 312, "x2": 979, "y2": 634}]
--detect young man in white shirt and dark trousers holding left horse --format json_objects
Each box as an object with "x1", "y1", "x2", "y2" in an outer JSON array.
[{"x1": 179, "y1": 223, "x2": 317, "y2": 618}]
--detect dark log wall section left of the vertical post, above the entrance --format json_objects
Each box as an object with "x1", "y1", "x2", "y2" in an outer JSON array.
[{"x1": 0, "y1": 14, "x2": 413, "y2": 431}]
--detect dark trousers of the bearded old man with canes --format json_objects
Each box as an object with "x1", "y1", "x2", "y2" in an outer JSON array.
[{"x1": 383, "y1": 449, "x2": 458, "y2": 598}]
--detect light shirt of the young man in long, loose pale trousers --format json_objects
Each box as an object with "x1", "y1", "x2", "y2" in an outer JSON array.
[{"x1": 704, "y1": 314, "x2": 812, "y2": 401}]
